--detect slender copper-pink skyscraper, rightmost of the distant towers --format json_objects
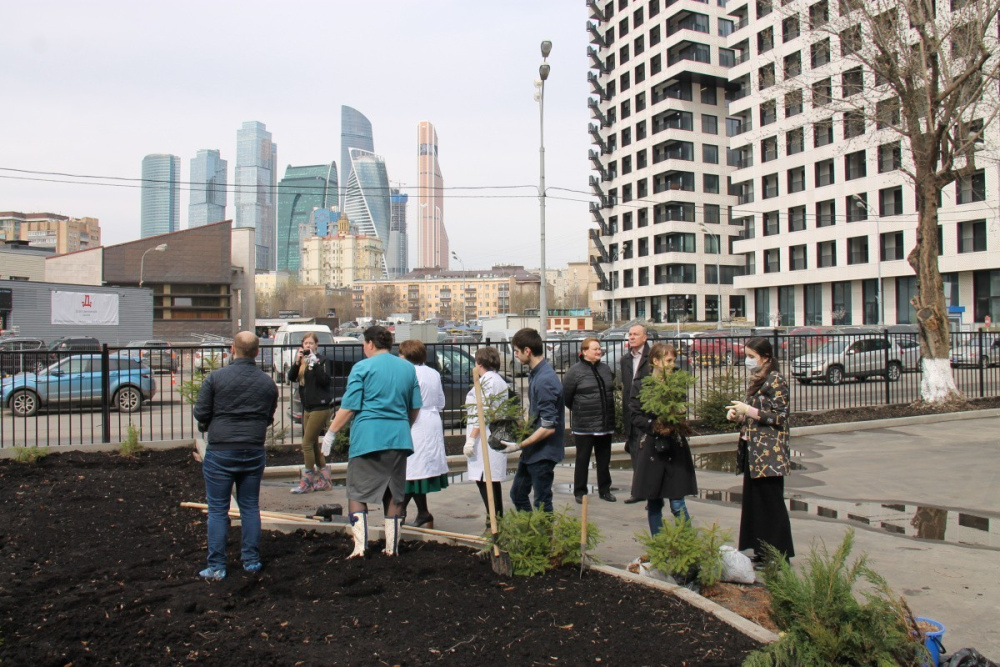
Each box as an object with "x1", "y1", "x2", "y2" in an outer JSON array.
[{"x1": 417, "y1": 121, "x2": 449, "y2": 269}]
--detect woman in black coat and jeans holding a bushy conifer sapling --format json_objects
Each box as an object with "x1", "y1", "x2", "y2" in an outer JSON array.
[{"x1": 629, "y1": 343, "x2": 698, "y2": 535}]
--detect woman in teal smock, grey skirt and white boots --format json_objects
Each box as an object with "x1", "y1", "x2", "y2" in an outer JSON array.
[{"x1": 323, "y1": 326, "x2": 422, "y2": 558}]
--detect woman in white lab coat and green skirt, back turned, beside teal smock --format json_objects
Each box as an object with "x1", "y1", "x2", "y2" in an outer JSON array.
[{"x1": 399, "y1": 340, "x2": 448, "y2": 528}]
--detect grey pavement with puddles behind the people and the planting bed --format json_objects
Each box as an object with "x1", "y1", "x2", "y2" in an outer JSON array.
[{"x1": 261, "y1": 413, "x2": 1000, "y2": 660}]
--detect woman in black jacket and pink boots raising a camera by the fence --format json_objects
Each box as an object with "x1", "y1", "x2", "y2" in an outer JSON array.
[{"x1": 288, "y1": 331, "x2": 332, "y2": 493}]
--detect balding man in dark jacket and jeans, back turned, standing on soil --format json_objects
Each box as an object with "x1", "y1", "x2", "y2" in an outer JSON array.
[{"x1": 192, "y1": 331, "x2": 278, "y2": 581}]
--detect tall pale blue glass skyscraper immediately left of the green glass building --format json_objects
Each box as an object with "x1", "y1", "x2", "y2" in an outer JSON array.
[{"x1": 235, "y1": 121, "x2": 278, "y2": 271}]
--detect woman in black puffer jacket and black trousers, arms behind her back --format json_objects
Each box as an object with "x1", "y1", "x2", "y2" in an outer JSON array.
[{"x1": 563, "y1": 338, "x2": 615, "y2": 503}]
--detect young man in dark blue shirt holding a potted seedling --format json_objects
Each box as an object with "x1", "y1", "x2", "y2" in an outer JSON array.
[{"x1": 504, "y1": 329, "x2": 566, "y2": 512}]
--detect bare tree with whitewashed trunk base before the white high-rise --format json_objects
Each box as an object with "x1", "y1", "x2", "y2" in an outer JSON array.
[{"x1": 809, "y1": 0, "x2": 1000, "y2": 403}]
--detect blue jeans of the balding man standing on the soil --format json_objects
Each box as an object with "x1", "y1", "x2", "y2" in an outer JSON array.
[{"x1": 201, "y1": 449, "x2": 266, "y2": 569}]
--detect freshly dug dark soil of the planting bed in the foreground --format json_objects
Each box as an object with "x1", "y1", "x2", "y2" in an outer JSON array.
[{"x1": 0, "y1": 450, "x2": 757, "y2": 667}]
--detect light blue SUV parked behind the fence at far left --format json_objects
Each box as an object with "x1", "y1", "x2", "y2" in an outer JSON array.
[{"x1": 0, "y1": 352, "x2": 156, "y2": 417}]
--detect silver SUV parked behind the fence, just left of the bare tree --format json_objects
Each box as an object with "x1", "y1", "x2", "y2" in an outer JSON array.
[{"x1": 792, "y1": 336, "x2": 903, "y2": 385}]
